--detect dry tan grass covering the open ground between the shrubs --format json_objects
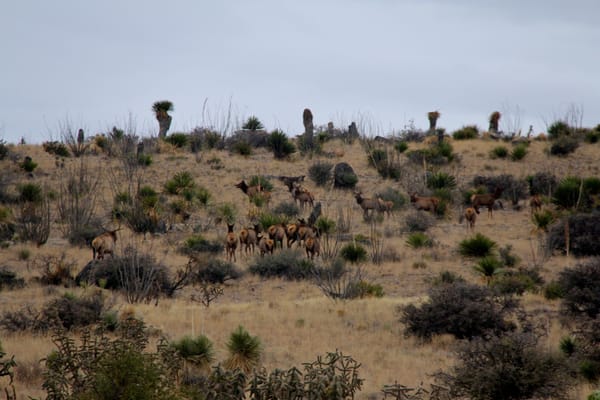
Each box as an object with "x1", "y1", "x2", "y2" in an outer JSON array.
[{"x1": 0, "y1": 140, "x2": 600, "y2": 399}]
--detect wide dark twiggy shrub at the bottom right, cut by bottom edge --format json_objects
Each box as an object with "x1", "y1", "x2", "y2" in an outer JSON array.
[{"x1": 436, "y1": 332, "x2": 575, "y2": 400}]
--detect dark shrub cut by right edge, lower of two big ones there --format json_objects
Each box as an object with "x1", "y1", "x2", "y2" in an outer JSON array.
[{"x1": 558, "y1": 258, "x2": 600, "y2": 318}]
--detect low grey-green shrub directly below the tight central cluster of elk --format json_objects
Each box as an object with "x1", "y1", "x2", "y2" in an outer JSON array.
[{"x1": 248, "y1": 249, "x2": 314, "y2": 280}]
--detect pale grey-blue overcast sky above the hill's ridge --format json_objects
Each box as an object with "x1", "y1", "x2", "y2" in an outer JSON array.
[{"x1": 0, "y1": 0, "x2": 600, "y2": 143}]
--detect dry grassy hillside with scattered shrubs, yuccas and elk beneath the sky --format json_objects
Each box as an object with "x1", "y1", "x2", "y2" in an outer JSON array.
[{"x1": 0, "y1": 108, "x2": 600, "y2": 399}]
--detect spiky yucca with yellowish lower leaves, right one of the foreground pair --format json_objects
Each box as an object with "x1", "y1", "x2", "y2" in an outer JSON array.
[{"x1": 224, "y1": 325, "x2": 262, "y2": 374}]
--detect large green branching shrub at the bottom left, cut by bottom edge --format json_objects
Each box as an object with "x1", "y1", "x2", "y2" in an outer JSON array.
[{"x1": 42, "y1": 318, "x2": 183, "y2": 400}]
